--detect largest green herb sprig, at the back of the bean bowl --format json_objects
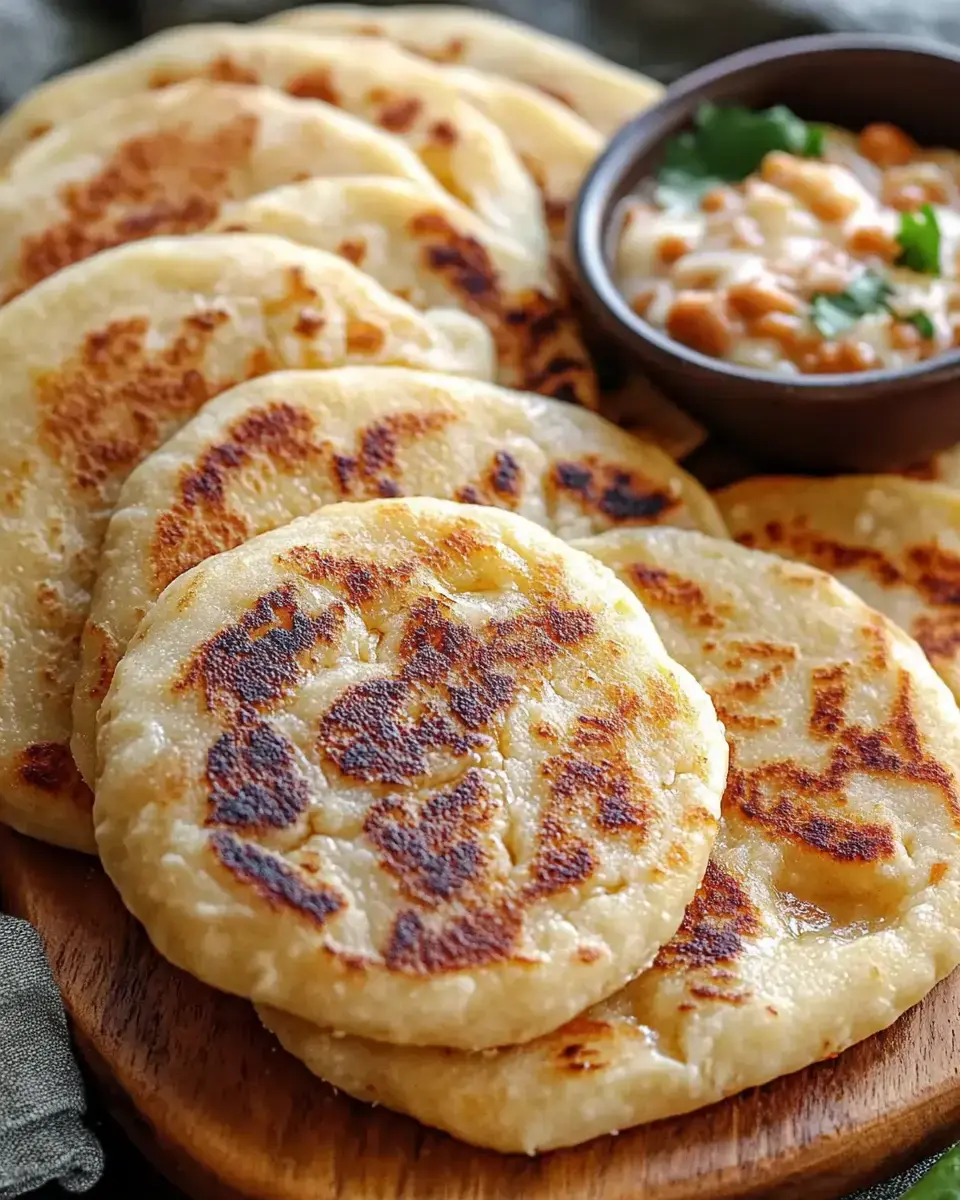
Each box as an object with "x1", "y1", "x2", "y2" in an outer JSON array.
[{"x1": 656, "y1": 103, "x2": 824, "y2": 209}]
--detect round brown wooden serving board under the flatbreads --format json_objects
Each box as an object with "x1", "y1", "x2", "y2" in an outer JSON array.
[{"x1": 0, "y1": 828, "x2": 960, "y2": 1200}]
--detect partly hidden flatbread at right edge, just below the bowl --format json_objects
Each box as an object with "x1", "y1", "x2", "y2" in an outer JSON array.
[{"x1": 716, "y1": 475, "x2": 960, "y2": 700}]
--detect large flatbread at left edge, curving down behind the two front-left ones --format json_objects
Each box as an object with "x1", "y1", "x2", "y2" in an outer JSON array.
[{"x1": 0, "y1": 234, "x2": 492, "y2": 850}]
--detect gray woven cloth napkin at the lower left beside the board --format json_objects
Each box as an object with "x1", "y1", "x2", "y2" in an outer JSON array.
[{"x1": 0, "y1": 916, "x2": 103, "y2": 1200}]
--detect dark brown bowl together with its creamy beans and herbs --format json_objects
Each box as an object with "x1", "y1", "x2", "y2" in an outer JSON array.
[{"x1": 571, "y1": 35, "x2": 960, "y2": 472}]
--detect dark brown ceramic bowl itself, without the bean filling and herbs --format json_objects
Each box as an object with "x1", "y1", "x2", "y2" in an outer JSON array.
[{"x1": 571, "y1": 34, "x2": 960, "y2": 472}]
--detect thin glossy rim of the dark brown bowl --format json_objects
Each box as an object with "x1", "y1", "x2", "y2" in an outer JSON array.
[{"x1": 569, "y1": 34, "x2": 960, "y2": 400}]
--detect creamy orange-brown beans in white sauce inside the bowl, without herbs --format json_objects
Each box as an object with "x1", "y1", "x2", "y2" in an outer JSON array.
[{"x1": 616, "y1": 125, "x2": 960, "y2": 374}]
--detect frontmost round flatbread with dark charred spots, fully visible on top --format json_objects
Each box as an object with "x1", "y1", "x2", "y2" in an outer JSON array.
[{"x1": 95, "y1": 499, "x2": 727, "y2": 1048}]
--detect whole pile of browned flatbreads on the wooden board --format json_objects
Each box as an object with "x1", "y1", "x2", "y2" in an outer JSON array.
[{"x1": 0, "y1": 5, "x2": 960, "y2": 1152}]
